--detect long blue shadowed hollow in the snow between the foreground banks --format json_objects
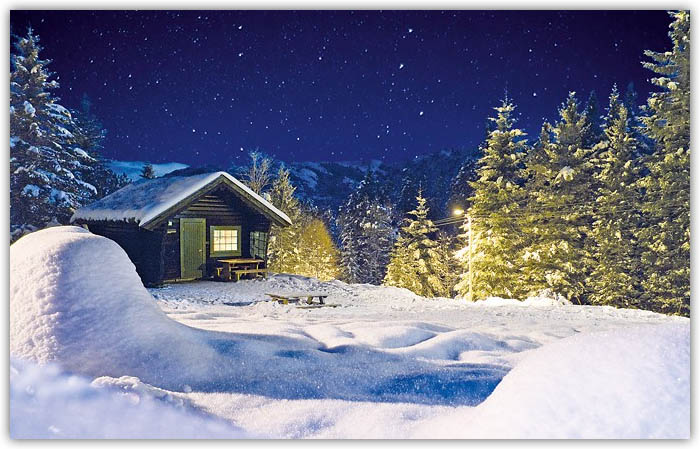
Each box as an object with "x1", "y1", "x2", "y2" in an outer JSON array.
[{"x1": 180, "y1": 330, "x2": 508, "y2": 406}]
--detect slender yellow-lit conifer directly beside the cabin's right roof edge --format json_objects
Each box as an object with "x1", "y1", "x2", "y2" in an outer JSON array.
[{"x1": 268, "y1": 167, "x2": 302, "y2": 273}]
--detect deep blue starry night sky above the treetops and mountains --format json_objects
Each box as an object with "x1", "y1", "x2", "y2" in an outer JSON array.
[{"x1": 10, "y1": 11, "x2": 670, "y2": 165}]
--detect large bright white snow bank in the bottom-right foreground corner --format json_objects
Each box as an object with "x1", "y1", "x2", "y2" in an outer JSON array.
[{"x1": 417, "y1": 324, "x2": 690, "y2": 438}]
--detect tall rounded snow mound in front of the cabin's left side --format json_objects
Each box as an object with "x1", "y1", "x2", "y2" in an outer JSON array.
[{"x1": 10, "y1": 226, "x2": 216, "y2": 388}]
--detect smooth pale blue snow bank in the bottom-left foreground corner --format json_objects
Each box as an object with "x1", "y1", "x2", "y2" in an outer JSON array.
[{"x1": 10, "y1": 359, "x2": 246, "y2": 439}]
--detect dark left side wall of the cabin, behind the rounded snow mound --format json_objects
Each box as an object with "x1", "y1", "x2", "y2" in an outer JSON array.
[{"x1": 88, "y1": 222, "x2": 163, "y2": 285}]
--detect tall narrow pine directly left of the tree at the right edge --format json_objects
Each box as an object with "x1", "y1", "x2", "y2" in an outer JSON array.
[{"x1": 588, "y1": 88, "x2": 643, "y2": 308}]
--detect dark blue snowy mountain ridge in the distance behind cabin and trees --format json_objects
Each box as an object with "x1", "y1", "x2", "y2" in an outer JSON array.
[{"x1": 109, "y1": 149, "x2": 478, "y2": 218}]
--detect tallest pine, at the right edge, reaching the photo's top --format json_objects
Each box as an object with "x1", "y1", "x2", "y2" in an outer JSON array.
[{"x1": 639, "y1": 11, "x2": 690, "y2": 315}]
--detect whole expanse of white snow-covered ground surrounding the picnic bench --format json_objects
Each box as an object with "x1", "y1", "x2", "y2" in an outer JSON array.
[{"x1": 10, "y1": 227, "x2": 690, "y2": 438}]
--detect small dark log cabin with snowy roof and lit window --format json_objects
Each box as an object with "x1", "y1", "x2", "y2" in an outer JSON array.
[{"x1": 71, "y1": 170, "x2": 291, "y2": 285}]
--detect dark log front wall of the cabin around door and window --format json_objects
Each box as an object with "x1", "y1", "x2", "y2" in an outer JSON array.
[{"x1": 164, "y1": 188, "x2": 270, "y2": 280}]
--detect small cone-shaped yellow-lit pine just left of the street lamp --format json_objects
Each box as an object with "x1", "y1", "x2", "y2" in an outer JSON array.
[{"x1": 384, "y1": 191, "x2": 451, "y2": 298}]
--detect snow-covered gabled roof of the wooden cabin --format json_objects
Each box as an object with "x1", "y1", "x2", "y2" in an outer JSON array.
[{"x1": 70, "y1": 171, "x2": 292, "y2": 229}]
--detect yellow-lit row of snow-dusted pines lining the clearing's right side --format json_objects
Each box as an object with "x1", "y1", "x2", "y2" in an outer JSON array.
[{"x1": 378, "y1": 11, "x2": 690, "y2": 315}]
